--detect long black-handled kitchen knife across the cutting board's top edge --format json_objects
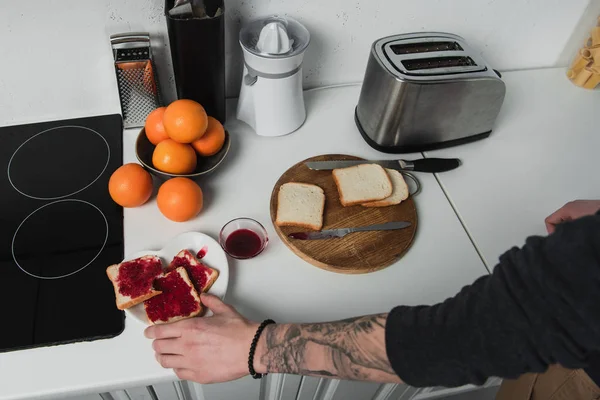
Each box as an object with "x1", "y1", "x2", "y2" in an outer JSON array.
[{"x1": 306, "y1": 158, "x2": 460, "y2": 173}]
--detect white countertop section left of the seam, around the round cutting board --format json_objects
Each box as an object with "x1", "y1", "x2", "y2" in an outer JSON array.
[{"x1": 0, "y1": 86, "x2": 486, "y2": 400}]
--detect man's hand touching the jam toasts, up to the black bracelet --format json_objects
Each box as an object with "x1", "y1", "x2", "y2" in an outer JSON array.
[{"x1": 145, "y1": 294, "x2": 258, "y2": 383}]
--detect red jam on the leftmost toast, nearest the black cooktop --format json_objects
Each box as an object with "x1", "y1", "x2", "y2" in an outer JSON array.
[{"x1": 117, "y1": 258, "x2": 162, "y2": 299}]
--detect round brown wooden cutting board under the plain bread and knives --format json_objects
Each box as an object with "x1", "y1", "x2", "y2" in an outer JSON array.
[{"x1": 271, "y1": 154, "x2": 417, "y2": 274}]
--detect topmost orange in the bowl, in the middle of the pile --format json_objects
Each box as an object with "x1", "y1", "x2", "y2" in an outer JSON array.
[{"x1": 163, "y1": 99, "x2": 208, "y2": 143}]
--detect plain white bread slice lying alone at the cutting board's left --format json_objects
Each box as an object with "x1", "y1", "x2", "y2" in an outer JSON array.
[{"x1": 275, "y1": 182, "x2": 325, "y2": 231}]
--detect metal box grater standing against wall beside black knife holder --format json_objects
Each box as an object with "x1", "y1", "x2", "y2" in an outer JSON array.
[{"x1": 110, "y1": 32, "x2": 162, "y2": 128}]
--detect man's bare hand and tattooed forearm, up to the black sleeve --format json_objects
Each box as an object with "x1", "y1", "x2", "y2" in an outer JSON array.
[{"x1": 146, "y1": 294, "x2": 401, "y2": 383}]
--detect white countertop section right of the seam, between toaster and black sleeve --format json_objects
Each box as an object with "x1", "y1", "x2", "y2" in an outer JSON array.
[{"x1": 427, "y1": 68, "x2": 600, "y2": 269}]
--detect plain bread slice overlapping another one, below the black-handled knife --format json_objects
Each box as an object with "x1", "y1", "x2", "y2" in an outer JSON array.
[{"x1": 333, "y1": 164, "x2": 393, "y2": 207}]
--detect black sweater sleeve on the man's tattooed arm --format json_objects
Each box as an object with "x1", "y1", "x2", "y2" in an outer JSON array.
[{"x1": 385, "y1": 214, "x2": 600, "y2": 387}]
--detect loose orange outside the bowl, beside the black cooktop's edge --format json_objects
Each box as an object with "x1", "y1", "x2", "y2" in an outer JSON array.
[{"x1": 108, "y1": 163, "x2": 152, "y2": 207}]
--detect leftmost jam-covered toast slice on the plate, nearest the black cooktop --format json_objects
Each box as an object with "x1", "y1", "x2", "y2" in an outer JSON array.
[{"x1": 106, "y1": 256, "x2": 163, "y2": 310}]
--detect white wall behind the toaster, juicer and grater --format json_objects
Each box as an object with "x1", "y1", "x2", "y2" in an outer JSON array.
[{"x1": 0, "y1": 0, "x2": 600, "y2": 123}]
